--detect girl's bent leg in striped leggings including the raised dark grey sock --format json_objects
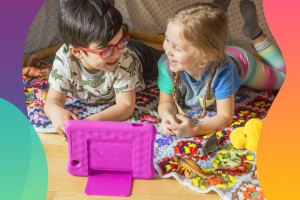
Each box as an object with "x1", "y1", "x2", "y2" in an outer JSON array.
[{"x1": 226, "y1": 0, "x2": 285, "y2": 90}]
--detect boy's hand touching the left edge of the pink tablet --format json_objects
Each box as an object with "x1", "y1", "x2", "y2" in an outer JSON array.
[{"x1": 52, "y1": 109, "x2": 78, "y2": 134}]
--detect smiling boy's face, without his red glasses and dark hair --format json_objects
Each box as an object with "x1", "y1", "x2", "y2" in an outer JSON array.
[{"x1": 69, "y1": 28, "x2": 125, "y2": 74}]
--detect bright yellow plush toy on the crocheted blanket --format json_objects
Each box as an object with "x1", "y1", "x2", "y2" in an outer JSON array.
[{"x1": 230, "y1": 118, "x2": 263, "y2": 151}]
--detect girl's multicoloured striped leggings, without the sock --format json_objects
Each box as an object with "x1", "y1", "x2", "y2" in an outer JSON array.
[{"x1": 226, "y1": 38, "x2": 286, "y2": 90}]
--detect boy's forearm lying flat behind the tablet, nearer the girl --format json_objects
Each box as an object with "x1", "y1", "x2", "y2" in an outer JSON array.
[{"x1": 86, "y1": 89, "x2": 135, "y2": 121}]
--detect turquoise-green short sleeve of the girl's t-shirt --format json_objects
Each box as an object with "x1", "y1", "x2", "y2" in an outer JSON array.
[{"x1": 157, "y1": 60, "x2": 173, "y2": 94}]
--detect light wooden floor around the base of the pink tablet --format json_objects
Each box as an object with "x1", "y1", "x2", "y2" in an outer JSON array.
[{"x1": 39, "y1": 133, "x2": 220, "y2": 200}]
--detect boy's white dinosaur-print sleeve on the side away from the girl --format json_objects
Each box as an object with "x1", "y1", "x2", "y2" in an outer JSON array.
[{"x1": 48, "y1": 52, "x2": 71, "y2": 93}]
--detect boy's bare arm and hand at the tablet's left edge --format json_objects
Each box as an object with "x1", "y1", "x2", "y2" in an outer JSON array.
[{"x1": 44, "y1": 87, "x2": 77, "y2": 134}]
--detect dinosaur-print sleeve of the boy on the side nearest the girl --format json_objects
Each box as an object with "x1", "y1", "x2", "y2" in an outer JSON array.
[{"x1": 113, "y1": 50, "x2": 145, "y2": 93}]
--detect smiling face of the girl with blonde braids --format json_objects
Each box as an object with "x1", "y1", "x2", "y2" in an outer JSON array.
[{"x1": 163, "y1": 22, "x2": 197, "y2": 72}]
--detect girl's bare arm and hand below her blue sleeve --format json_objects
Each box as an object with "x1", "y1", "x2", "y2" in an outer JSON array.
[{"x1": 174, "y1": 94, "x2": 234, "y2": 137}]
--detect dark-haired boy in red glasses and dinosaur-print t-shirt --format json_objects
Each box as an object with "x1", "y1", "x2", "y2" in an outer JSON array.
[{"x1": 44, "y1": 0, "x2": 161, "y2": 133}]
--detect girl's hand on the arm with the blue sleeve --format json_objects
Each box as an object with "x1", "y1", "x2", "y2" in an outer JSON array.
[{"x1": 172, "y1": 114, "x2": 195, "y2": 137}]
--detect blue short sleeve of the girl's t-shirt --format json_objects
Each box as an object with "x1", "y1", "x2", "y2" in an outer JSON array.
[{"x1": 214, "y1": 62, "x2": 242, "y2": 100}]
